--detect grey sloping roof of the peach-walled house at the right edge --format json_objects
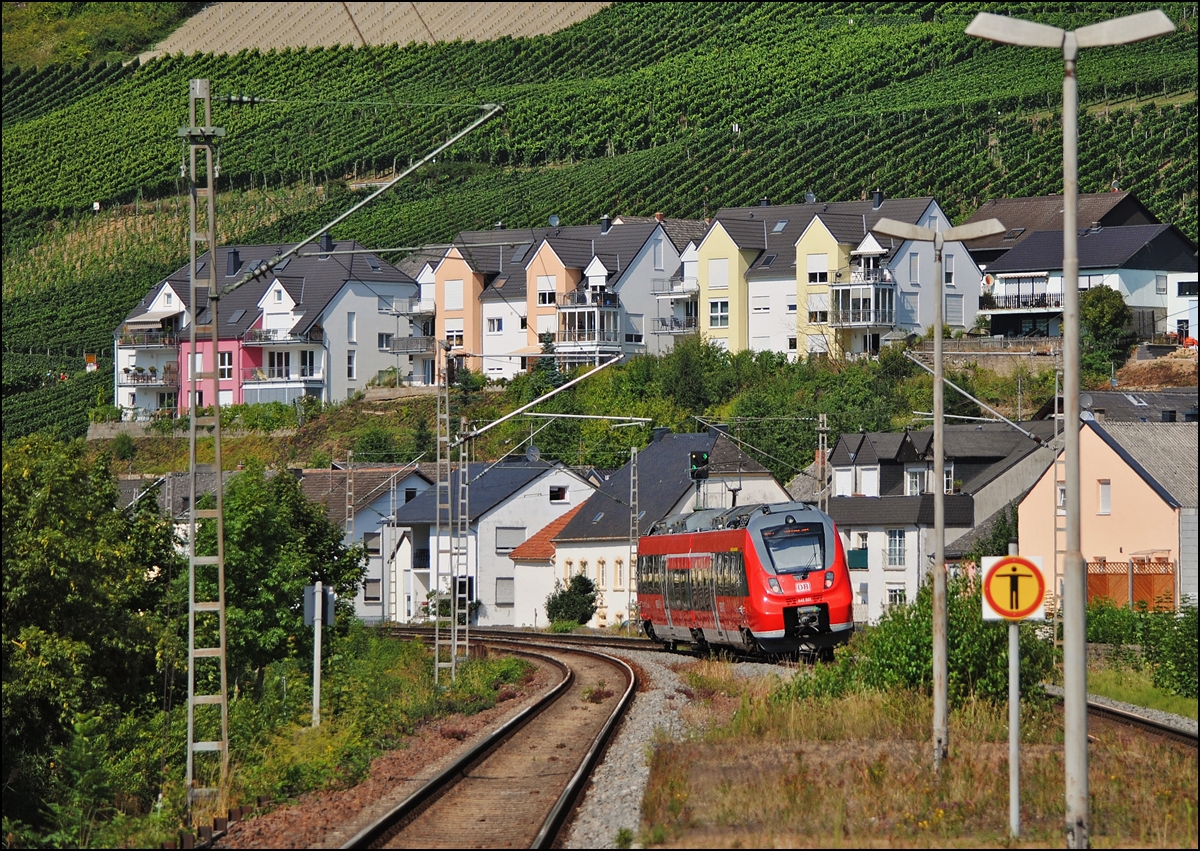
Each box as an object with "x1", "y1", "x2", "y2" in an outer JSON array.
[{"x1": 1085, "y1": 422, "x2": 1198, "y2": 508}]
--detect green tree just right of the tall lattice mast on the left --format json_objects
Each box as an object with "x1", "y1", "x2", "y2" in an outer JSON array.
[{"x1": 192, "y1": 460, "x2": 366, "y2": 688}]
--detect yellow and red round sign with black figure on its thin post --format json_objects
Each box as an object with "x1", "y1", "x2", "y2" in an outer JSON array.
[{"x1": 982, "y1": 541, "x2": 1046, "y2": 838}]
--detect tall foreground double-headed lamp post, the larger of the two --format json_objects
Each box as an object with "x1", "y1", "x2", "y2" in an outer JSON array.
[{"x1": 966, "y1": 10, "x2": 1175, "y2": 849}]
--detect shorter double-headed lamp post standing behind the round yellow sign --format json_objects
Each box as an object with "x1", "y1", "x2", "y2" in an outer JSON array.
[{"x1": 871, "y1": 212, "x2": 1004, "y2": 773}]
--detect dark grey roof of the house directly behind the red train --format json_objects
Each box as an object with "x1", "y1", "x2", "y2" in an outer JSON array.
[{"x1": 554, "y1": 430, "x2": 770, "y2": 541}]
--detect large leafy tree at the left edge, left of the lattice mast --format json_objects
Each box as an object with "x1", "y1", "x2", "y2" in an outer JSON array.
[{"x1": 2, "y1": 436, "x2": 180, "y2": 821}]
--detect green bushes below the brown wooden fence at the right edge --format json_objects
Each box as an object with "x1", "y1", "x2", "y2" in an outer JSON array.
[{"x1": 1087, "y1": 597, "x2": 1198, "y2": 697}]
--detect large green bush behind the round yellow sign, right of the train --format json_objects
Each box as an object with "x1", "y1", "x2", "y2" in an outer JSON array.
[{"x1": 776, "y1": 577, "x2": 1054, "y2": 705}]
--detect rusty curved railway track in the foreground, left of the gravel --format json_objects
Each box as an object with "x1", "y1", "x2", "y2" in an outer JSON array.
[{"x1": 342, "y1": 630, "x2": 633, "y2": 849}]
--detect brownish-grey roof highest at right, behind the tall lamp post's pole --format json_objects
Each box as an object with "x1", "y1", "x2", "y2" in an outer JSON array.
[{"x1": 964, "y1": 192, "x2": 1158, "y2": 255}]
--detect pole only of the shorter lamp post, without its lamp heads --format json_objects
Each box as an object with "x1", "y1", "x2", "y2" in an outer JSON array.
[{"x1": 934, "y1": 230, "x2": 950, "y2": 775}]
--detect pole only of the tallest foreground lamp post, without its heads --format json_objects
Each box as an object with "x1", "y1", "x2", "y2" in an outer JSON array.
[{"x1": 1062, "y1": 32, "x2": 1090, "y2": 849}]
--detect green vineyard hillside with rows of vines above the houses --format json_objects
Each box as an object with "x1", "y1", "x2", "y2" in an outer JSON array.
[{"x1": 2, "y1": 2, "x2": 1198, "y2": 437}]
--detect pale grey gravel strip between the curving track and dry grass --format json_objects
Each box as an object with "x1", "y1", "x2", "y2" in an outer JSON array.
[{"x1": 565, "y1": 648, "x2": 796, "y2": 849}]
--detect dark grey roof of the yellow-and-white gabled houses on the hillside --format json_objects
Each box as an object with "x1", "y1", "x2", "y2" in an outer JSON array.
[{"x1": 716, "y1": 196, "x2": 934, "y2": 278}]
